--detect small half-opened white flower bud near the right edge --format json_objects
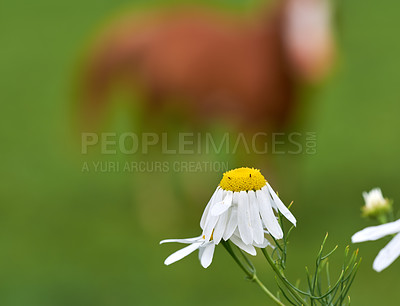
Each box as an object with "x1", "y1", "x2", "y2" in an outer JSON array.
[{"x1": 362, "y1": 188, "x2": 392, "y2": 217}]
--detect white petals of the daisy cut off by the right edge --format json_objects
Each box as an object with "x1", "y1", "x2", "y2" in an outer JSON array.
[{"x1": 351, "y1": 219, "x2": 400, "y2": 272}]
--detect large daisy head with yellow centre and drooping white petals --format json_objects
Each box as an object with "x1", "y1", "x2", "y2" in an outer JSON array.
[{"x1": 161, "y1": 168, "x2": 296, "y2": 268}]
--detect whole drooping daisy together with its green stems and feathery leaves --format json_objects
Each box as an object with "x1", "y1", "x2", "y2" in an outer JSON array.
[{"x1": 161, "y1": 168, "x2": 360, "y2": 305}]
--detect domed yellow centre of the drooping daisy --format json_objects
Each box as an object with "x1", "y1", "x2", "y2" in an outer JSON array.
[{"x1": 219, "y1": 167, "x2": 267, "y2": 192}]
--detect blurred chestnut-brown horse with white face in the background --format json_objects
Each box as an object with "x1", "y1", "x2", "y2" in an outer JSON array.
[{"x1": 83, "y1": 0, "x2": 333, "y2": 130}]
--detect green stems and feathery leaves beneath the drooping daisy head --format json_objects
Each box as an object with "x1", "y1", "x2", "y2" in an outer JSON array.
[{"x1": 222, "y1": 207, "x2": 361, "y2": 306}]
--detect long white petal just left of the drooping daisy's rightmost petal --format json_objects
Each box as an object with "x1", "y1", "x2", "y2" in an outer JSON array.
[{"x1": 256, "y1": 191, "x2": 283, "y2": 239}]
